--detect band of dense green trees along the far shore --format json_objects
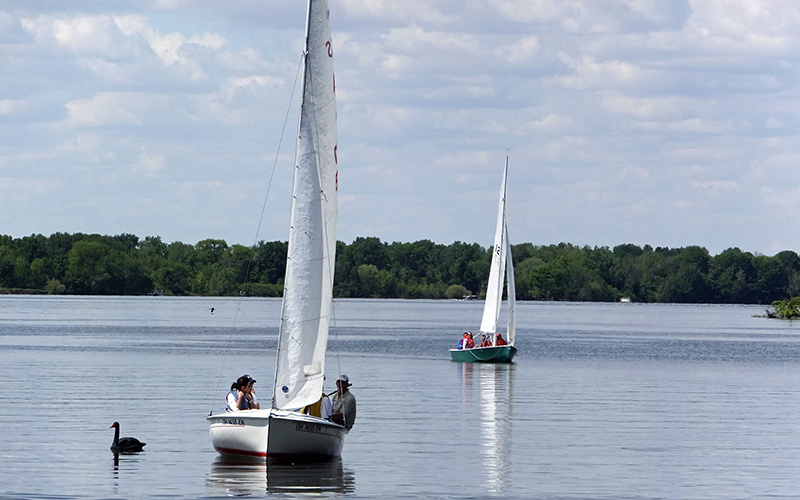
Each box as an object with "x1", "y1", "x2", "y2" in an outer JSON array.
[{"x1": 0, "y1": 233, "x2": 800, "y2": 306}]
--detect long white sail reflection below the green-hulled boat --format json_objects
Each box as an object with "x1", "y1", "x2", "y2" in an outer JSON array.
[{"x1": 459, "y1": 363, "x2": 514, "y2": 494}]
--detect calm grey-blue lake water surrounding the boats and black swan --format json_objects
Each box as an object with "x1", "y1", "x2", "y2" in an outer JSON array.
[{"x1": 0, "y1": 296, "x2": 800, "y2": 499}]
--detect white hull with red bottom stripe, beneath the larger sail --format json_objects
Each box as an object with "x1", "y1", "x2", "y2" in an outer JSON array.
[{"x1": 208, "y1": 409, "x2": 347, "y2": 459}]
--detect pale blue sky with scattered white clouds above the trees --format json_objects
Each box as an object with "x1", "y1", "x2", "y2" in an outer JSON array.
[{"x1": 0, "y1": 0, "x2": 800, "y2": 255}]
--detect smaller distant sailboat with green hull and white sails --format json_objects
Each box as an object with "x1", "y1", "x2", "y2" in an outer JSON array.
[{"x1": 450, "y1": 157, "x2": 517, "y2": 363}]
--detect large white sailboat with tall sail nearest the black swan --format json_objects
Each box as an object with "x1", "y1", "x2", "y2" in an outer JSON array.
[{"x1": 208, "y1": 0, "x2": 347, "y2": 459}]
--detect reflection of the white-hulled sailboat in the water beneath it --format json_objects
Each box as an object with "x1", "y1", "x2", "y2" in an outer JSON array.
[{"x1": 208, "y1": 457, "x2": 355, "y2": 496}]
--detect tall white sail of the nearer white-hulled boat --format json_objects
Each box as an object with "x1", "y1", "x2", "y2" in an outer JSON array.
[{"x1": 272, "y1": 0, "x2": 338, "y2": 409}]
